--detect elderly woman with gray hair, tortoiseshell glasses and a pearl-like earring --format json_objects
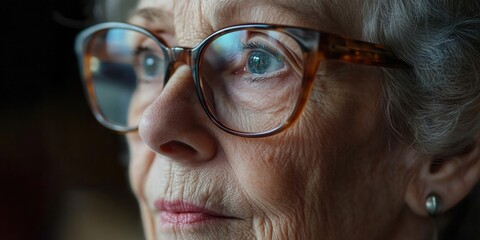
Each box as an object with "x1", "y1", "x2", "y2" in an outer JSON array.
[{"x1": 76, "y1": 0, "x2": 480, "y2": 240}]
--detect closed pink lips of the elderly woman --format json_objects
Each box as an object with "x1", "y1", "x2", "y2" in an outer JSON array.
[{"x1": 154, "y1": 200, "x2": 231, "y2": 225}]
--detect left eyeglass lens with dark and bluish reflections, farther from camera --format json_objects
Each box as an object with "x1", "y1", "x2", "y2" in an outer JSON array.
[{"x1": 86, "y1": 28, "x2": 166, "y2": 127}]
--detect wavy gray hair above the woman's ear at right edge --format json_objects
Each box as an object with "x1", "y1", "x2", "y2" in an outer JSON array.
[{"x1": 362, "y1": 0, "x2": 480, "y2": 157}]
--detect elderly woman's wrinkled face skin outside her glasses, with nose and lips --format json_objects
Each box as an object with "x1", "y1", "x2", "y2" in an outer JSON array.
[{"x1": 128, "y1": 0, "x2": 411, "y2": 239}]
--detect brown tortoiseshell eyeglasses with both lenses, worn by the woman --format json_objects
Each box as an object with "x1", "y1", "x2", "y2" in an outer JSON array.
[{"x1": 75, "y1": 22, "x2": 408, "y2": 137}]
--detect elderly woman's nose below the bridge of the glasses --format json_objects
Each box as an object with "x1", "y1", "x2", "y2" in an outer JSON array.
[{"x1": 138, "y1": 62, "x2": 217, "y2": 164}]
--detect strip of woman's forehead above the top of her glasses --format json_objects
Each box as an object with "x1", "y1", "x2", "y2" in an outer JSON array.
[{"x1": 133, "y1": 0, "x2": 363, "y2": 35}]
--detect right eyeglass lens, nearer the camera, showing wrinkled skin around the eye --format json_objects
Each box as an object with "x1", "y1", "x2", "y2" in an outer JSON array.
[{"x1": 199, "y1": 30, "x2": 303, "y2": 133}]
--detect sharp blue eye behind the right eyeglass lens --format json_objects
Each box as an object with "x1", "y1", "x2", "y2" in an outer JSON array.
[{"x1": 247, "y1": 50, "x2": 285, "y2": 74}]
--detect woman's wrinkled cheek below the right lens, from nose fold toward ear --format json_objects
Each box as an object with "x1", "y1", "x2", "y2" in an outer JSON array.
[{"x1": 220, "y1": 66, "x2": 392, "y2": 226}]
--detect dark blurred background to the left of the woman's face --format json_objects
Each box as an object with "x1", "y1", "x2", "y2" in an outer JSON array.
[{"x1": 0, "y1": 0, "x2": 142, "y2": 240}]
